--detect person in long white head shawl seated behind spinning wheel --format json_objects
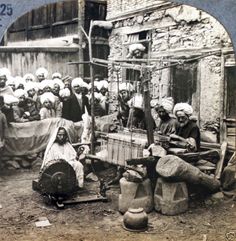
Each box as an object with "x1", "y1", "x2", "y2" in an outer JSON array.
[{"x1": 41, "y1": 127, "x2": 84, "y2": 188}]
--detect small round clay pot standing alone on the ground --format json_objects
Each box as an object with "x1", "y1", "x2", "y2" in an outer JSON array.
[{"x1": 123, "y1": 208, "x2": 148, "y2": 231}]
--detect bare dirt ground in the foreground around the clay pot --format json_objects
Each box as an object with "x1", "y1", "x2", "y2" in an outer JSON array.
[{"x1": 0, "y1": 166, "x2": 236, "y2": 241}]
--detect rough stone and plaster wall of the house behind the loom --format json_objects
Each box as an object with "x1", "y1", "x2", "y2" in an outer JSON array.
[{"x1": 108, "y1": 1, "x2": 232, "y2": 124}]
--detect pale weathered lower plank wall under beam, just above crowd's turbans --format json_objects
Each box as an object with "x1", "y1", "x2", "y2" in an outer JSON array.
[{"x1": 0, "y1": 47, "x2": 78, "y2": 78}]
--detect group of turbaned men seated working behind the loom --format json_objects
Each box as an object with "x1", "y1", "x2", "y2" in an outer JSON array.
[{"x1": 117, "y1": 84, "x2": 200, "y2": 151}]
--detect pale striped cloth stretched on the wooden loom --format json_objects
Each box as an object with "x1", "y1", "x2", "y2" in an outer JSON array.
[{"x1": 101, "y1": 132, "x2": 147, "y2": 166}]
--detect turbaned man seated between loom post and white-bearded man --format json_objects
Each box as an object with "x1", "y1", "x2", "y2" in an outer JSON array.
[{"x1": 155, "y1": 97, "x2": 176, "y2": 135}]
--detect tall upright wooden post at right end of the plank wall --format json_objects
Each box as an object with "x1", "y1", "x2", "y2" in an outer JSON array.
[{"x1": 78, "y1": 0, "x2": 85, "y2": 76}]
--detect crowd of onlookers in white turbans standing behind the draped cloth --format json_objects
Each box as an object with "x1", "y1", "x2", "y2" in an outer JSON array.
[{"x1": 0, "y1": 68, "x2": 108, "y2": 123}]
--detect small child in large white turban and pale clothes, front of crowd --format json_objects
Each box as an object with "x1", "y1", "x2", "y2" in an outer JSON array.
[{"x1": 39, "y1": 92, "x2": 56, "y2": 120}]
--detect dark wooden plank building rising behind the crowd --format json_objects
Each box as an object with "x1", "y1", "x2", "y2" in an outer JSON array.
[{"x1": 0, "y1": 0, "x2": 109, "y2": 77}]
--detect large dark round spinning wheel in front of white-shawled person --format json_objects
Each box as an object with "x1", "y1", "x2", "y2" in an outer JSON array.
[{"x1": 39, "y1": 159, "x2": 77, "y2": 196}]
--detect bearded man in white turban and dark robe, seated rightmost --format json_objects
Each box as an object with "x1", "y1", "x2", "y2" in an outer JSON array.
[{"x1": 171, "y1": 103, "x2": 200, "y2": 152}]
